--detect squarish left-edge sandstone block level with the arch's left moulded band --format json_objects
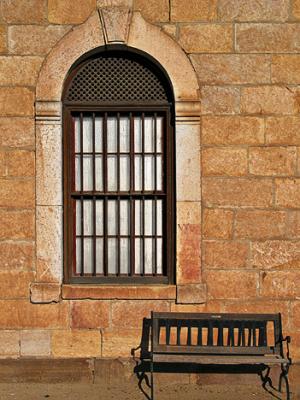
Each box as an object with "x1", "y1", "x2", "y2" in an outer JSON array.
[{"x1": 0, "y1": 87, "x2": 34, "y2": 117}]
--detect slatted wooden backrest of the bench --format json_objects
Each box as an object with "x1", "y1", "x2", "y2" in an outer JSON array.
[{"x1": 151, "y1": 312, "x2": 282, "y2": 355}]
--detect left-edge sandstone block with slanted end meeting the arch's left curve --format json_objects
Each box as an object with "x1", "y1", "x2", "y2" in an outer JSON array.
[{"x1": 0, "y1": 56, "x2": 43, "y2": 86}]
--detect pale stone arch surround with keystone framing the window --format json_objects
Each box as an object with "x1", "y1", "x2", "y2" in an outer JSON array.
[{"x1": 35, "y1": 3, "x2": 201, "y2": 302}]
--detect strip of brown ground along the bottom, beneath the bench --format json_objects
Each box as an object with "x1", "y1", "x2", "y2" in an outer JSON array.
[{"x1": 0, "y1": 382, "x2": 300, "y2": 400}]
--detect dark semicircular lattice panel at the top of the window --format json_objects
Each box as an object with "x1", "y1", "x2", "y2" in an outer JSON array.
[{"x1": 65, "y1": 56, "x2": 168, "y2": 102}]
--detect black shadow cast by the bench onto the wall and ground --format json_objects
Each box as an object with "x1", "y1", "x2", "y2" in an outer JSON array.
[{"x1": 131, "y1": 318, "x2": 283, "y2": 400}]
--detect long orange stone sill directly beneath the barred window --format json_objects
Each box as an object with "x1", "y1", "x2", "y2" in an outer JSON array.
[{"x1": 62, "y1": 285, "x2": 176, "y2": 300}]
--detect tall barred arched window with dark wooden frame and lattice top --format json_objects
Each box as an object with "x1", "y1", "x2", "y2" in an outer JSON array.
[{"x1": 63, "y1": 46, "x2": 175, "y2": 284}]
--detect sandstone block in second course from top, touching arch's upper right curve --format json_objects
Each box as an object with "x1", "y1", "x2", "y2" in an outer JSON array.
[{"x1": 179, "y1": 24, "x2": 233, "y2": 53}]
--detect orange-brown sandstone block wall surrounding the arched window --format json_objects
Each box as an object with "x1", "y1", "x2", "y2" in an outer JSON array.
[{"x1": 0, "y1": 0, "x2": 300, "y2": 360}]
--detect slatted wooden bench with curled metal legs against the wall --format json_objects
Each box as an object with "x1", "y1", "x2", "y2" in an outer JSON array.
[{"x1": 150, "y1": 312, "x2": 291, "y2": 400}]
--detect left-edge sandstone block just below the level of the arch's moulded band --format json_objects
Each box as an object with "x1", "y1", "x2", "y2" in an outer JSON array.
[{"x1": 0, "y1": 117, "x2": 35, "y2": 147}]
